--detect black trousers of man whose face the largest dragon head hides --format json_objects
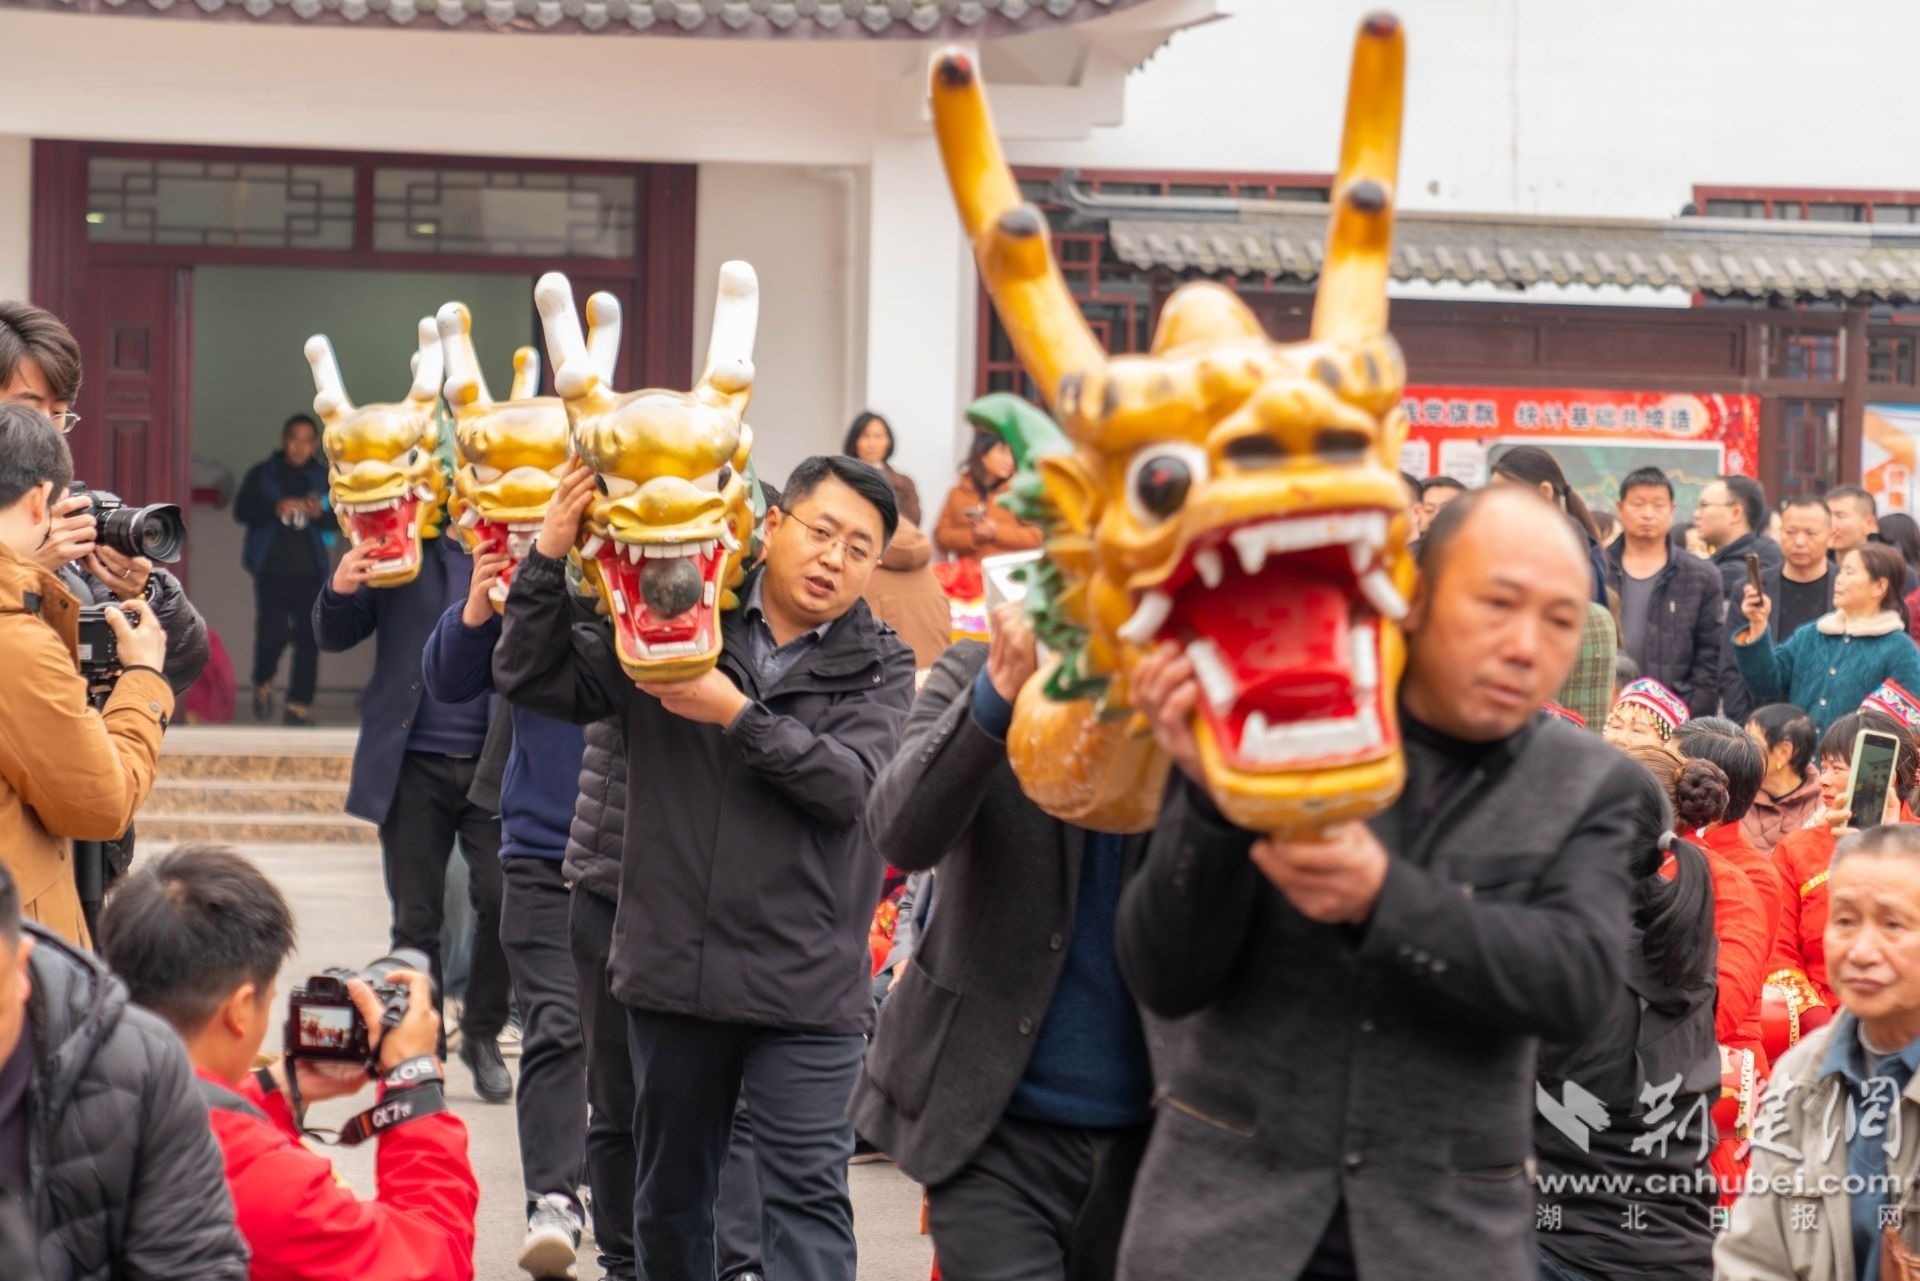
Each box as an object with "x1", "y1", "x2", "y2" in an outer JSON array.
[{"x1": 927, "y1": 1116, "x2": 1148, "y2": 1281}]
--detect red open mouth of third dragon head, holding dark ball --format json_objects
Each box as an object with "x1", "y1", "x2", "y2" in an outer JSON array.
[{"x1": 580, "y1": 526, "x2": 739, "y2": 665}]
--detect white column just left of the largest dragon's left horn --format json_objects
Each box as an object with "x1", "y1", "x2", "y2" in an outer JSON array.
[{"x1": 866, "y1": 133, "x2": 979, "y2": 526}]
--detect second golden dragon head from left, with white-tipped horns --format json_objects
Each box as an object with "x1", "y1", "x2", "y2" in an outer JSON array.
[{"x1": 438, "y1": 294, "x2": 595, "y2": 611}]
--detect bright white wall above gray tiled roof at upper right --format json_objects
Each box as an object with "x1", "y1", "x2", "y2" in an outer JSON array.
[{"x1": 1008, "y1": 0, "x2": 1920, "y2": 217}]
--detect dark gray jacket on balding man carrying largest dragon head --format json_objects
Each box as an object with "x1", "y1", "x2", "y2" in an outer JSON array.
[{"x1": 1117, "y1": 714, "x2": 1636, "y2": 1281}]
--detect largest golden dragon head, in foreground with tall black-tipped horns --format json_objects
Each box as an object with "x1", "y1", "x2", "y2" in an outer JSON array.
[{"x1": 931, "y1": 15, "x2": 1415, "y2": 832}]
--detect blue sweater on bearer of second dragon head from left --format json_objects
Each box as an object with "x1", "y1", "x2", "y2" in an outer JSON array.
[{"x1": 420, "y1": 603, "x2": 586, "y2": 860}]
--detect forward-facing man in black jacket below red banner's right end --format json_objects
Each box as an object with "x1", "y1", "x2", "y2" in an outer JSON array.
[{"x1": 1607, "y1": 467, "x2": 1726, "y2": 716}]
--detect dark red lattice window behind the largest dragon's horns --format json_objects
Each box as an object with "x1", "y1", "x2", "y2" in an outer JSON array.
[{"x1": 975, "y1": 169, "x2": 1329, "y2": 399}]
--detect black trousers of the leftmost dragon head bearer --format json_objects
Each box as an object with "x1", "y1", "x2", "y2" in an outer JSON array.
[{"x1": 380, "y1": 751, "x2": 509, "y2": 1041}]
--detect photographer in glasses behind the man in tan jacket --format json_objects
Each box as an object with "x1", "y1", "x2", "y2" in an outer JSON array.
[{"x1": 0, "y1": 300, "x2": 209, "y2": 695}]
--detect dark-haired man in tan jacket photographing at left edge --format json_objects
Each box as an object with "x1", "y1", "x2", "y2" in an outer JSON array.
[{"x1": 0, "y1": 403, "x2": 173, "y2": 945}]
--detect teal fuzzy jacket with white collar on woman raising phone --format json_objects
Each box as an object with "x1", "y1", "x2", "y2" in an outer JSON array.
[{"x1": 1734, "y1": 611, "x2": 1920, "y2": 732}]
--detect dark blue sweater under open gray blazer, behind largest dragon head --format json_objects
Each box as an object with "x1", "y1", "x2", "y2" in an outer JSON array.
[{"x1": 973, "y1": 668, "x2": 1154, "y2": 1129}]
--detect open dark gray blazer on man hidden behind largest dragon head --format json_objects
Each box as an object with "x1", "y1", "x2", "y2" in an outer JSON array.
[{"x1": 852, "y1": 641, "x2": 1154, "y2": 1185}]
